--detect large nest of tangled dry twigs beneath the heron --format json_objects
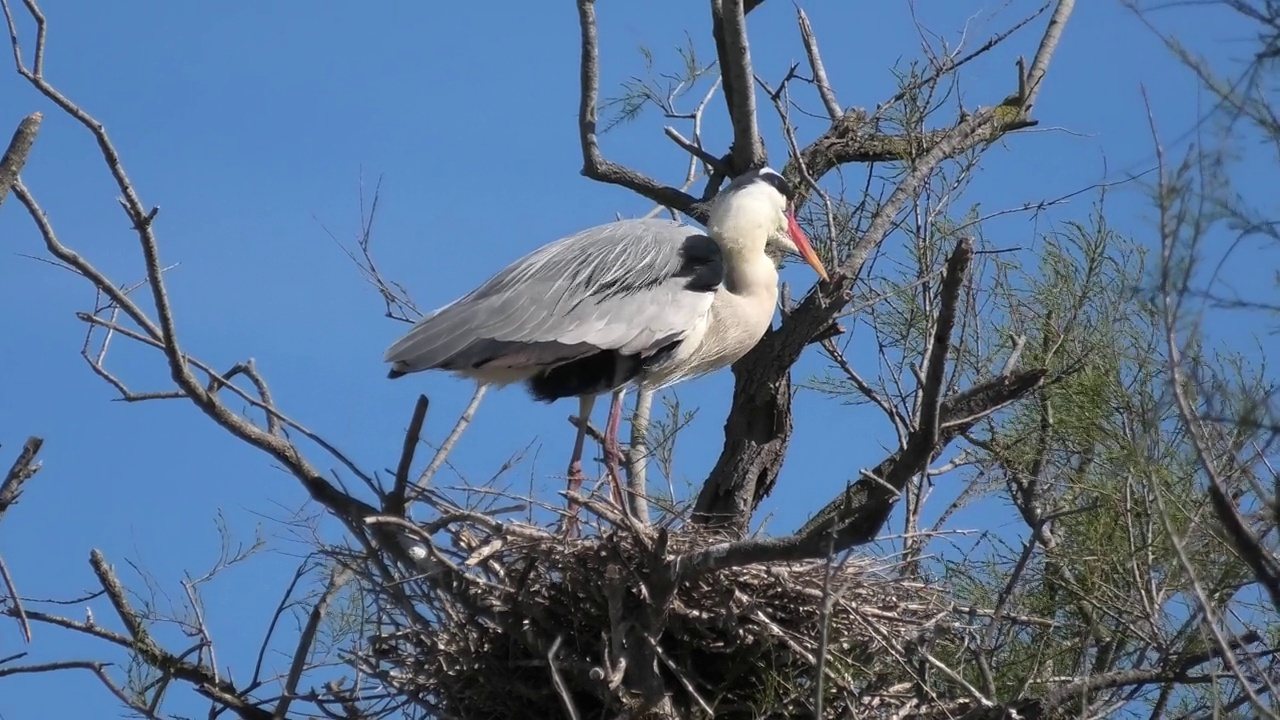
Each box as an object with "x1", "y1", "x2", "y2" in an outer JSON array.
[{"x1": 357, "y1": 507, "x2": 951, "y2": 719}]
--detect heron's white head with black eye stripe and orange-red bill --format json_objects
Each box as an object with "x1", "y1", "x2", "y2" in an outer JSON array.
[{"x1": 708, "y1": 168, "x2": 828, "y2": 281}]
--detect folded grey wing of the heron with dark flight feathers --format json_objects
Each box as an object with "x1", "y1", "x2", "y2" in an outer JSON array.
[{"x1": 385, "y1": 219, "x2": 724, "y2": 375}]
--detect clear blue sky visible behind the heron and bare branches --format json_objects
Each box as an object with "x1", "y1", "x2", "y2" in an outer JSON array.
[{"x1": 0, "y1": 0, "x2": 1274, "y2": 720}]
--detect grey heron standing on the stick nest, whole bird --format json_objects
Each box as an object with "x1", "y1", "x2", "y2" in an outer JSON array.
[{"x1": 384, "y1": 168, "x2": 827, "y2": 525}]
